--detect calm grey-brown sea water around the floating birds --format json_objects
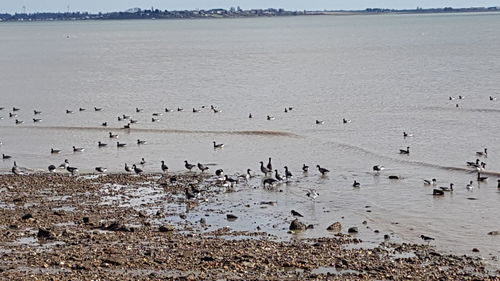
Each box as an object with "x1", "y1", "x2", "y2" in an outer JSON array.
[{"x1": 0, "y1": 14, "x2": 500, "y2": 268}]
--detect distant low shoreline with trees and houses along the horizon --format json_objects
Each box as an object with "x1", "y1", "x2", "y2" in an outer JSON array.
[{"x1": 0, "y1": 7, "x2": 500, "y2": 22}]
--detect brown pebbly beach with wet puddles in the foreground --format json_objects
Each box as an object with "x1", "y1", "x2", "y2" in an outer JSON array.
[{"x1": 0, "y1": 173, "x2": 500, "y2": 280}]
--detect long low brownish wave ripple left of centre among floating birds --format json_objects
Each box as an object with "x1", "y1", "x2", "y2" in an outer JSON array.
[{"x1": 0, "y1": 126, "x2": 300, "y2": 138}]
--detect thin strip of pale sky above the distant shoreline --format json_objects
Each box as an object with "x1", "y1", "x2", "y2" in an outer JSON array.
[{"x1": 0, "y1": 0, "x2": 500, "y2": 13}]
